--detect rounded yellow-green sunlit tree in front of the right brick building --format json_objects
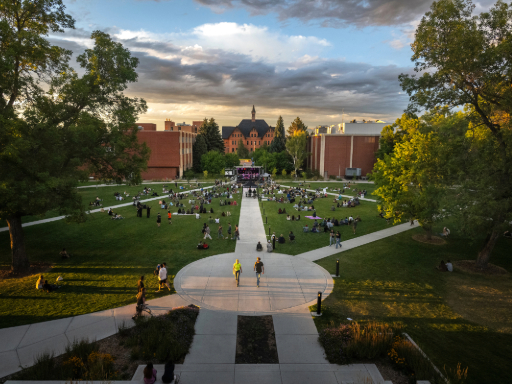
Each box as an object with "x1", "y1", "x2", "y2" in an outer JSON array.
[{"x1": 373, "y1": 115, "x2": 448, "y2": 240}]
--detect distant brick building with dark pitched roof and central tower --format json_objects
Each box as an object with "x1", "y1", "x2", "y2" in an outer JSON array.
[{"x1": 222, "y1": 105, "x2": 275, "y2": 153}]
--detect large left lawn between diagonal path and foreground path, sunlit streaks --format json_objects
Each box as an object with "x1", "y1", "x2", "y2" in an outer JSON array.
[{"x1": 0, "y1": 194, "x2": 241, "y2": 328}]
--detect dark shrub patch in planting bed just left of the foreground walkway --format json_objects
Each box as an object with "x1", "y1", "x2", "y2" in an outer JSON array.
[{"x1": 125, "y1": 307, "x2": 199, "y2": 363}]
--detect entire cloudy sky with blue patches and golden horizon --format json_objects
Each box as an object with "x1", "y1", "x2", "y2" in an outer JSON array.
[{"x1": 51, "y1": 0, "x2": 487, "y2": 129}]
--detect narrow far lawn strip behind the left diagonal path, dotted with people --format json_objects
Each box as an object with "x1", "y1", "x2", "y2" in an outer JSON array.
[{"x1": 0, "y1": 183, "x2": 212, "y2": 227}]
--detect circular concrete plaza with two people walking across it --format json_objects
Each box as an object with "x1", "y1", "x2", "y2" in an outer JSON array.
[{"x1": 174, "y1": 252, "x2": 333, "y2": 313}]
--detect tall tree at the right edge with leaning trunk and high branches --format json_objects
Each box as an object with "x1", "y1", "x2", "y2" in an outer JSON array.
[{"x1": 399, "y1": 0, "x2": 512, "y2": 266}]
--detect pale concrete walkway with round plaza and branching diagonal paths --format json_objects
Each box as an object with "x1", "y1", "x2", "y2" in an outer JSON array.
[{"x1": 0, "y1": 190, "x2": 411, "y2": 384}]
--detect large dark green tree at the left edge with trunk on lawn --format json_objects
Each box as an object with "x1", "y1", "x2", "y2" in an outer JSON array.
[{"x1": 0, "y1": 0, "x2": 149, "y2": 273}]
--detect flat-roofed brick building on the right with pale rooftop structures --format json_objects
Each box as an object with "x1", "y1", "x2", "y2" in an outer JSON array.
[{"x1": 306, "y1": 123, "x2": 388, "y2": 177}]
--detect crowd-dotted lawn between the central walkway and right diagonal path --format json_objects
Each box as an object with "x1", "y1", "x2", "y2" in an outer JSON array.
[{"x1": 261, "y1": 190, "x2": 388, "y2": 255}]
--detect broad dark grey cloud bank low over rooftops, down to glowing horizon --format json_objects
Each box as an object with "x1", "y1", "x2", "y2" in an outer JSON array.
[{"x1": 52, "y1": 26, "x2": 412, "y2": 125}]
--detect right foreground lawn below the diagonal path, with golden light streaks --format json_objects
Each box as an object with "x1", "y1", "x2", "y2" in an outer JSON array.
[{"x1": 315, "y1": 224, "x2": 512, "y2": 384}]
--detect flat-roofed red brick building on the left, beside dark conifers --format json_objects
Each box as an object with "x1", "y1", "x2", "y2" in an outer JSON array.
[{"x1": 137, "y1": 120, "x2": 197, "y2": 180}]
